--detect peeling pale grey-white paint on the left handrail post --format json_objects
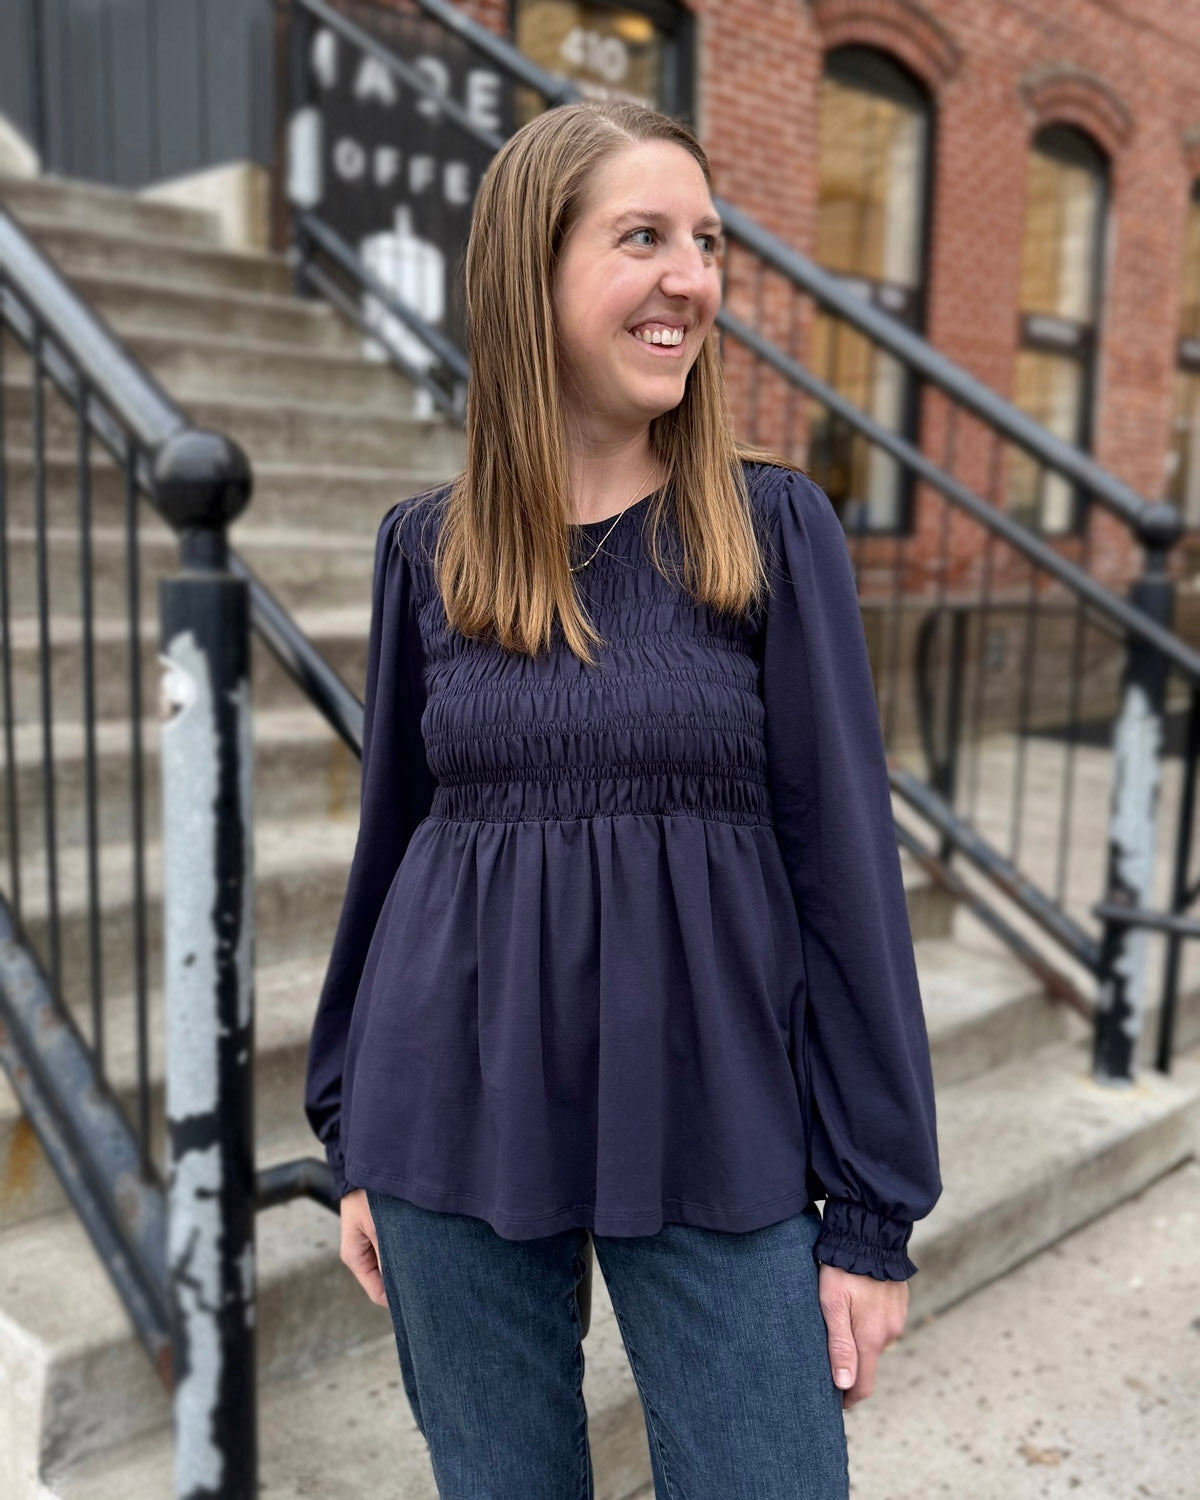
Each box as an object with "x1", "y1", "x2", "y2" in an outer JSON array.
[{"x1": 161, "y1": 603, "x2": 257, "y2": 1500}]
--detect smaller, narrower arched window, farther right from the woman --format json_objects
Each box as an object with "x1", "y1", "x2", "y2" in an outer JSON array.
[{"x1": 1008, "y1": 125, "x2": 1109, "y2": 536}]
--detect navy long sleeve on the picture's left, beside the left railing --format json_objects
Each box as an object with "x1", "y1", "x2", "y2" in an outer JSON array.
[{"x1": 305, "y1": 501, "x2": 437, "y2": 1197}]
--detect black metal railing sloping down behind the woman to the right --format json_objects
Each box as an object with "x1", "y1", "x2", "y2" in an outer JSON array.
[{"x1": 288, "y1": 0, "x2": 1200, "y2": 1082}]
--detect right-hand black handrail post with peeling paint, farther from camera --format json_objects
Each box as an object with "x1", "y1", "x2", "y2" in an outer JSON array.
[{"x1": 1092, "y1": 504, "x2": 1181, "y2": 1085}]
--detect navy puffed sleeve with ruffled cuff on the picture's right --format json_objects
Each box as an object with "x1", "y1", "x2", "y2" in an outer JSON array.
[{"x1": 761, "y1": 467, "x2": 942, "y2": 1281}]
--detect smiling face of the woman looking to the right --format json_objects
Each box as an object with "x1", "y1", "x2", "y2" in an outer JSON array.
[{"x1": 554, "y1": 141, "x2": 722, "y2": 438}]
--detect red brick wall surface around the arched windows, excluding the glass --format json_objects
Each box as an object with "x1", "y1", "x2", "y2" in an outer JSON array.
[{"x1": 372, "y1": 0, "x2": 1200, "y2": 585}]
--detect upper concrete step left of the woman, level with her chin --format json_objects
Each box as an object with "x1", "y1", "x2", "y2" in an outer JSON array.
[{"x1": 123, "y1": 326, "x2": 413, "y2": 417}]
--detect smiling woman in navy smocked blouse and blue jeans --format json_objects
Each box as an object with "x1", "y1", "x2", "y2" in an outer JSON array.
[{"x1": 306, "y1": 104, "x2": 941, "y2": 1500}]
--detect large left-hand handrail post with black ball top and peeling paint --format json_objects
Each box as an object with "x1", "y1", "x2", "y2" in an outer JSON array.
[{"x1": 153, "y1": 429, "x2": 258, "y2": 1500}]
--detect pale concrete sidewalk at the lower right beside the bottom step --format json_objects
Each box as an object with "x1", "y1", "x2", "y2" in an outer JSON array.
[{"x1": 846, "y1": 1158, "x2": 1200, "y2": 1500}]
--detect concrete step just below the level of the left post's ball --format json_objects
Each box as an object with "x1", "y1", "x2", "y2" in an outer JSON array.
[{"x1": 0, "y1": 522, "x2": 375, "y2": 621}]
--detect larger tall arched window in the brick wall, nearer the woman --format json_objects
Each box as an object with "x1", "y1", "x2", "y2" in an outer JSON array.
[{"x1": 806, "y1": 45, "x2": 933, "y2": 531}]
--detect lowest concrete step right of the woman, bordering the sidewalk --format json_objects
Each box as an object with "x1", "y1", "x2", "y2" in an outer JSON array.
[{"x1": 909, "y1": 1038, "x2": 1200, "y2": 1323}]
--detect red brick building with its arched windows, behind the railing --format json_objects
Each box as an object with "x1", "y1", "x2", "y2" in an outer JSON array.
[{"x1": 382, "y1": 0, "x2": 1200, "y2": 579}]
